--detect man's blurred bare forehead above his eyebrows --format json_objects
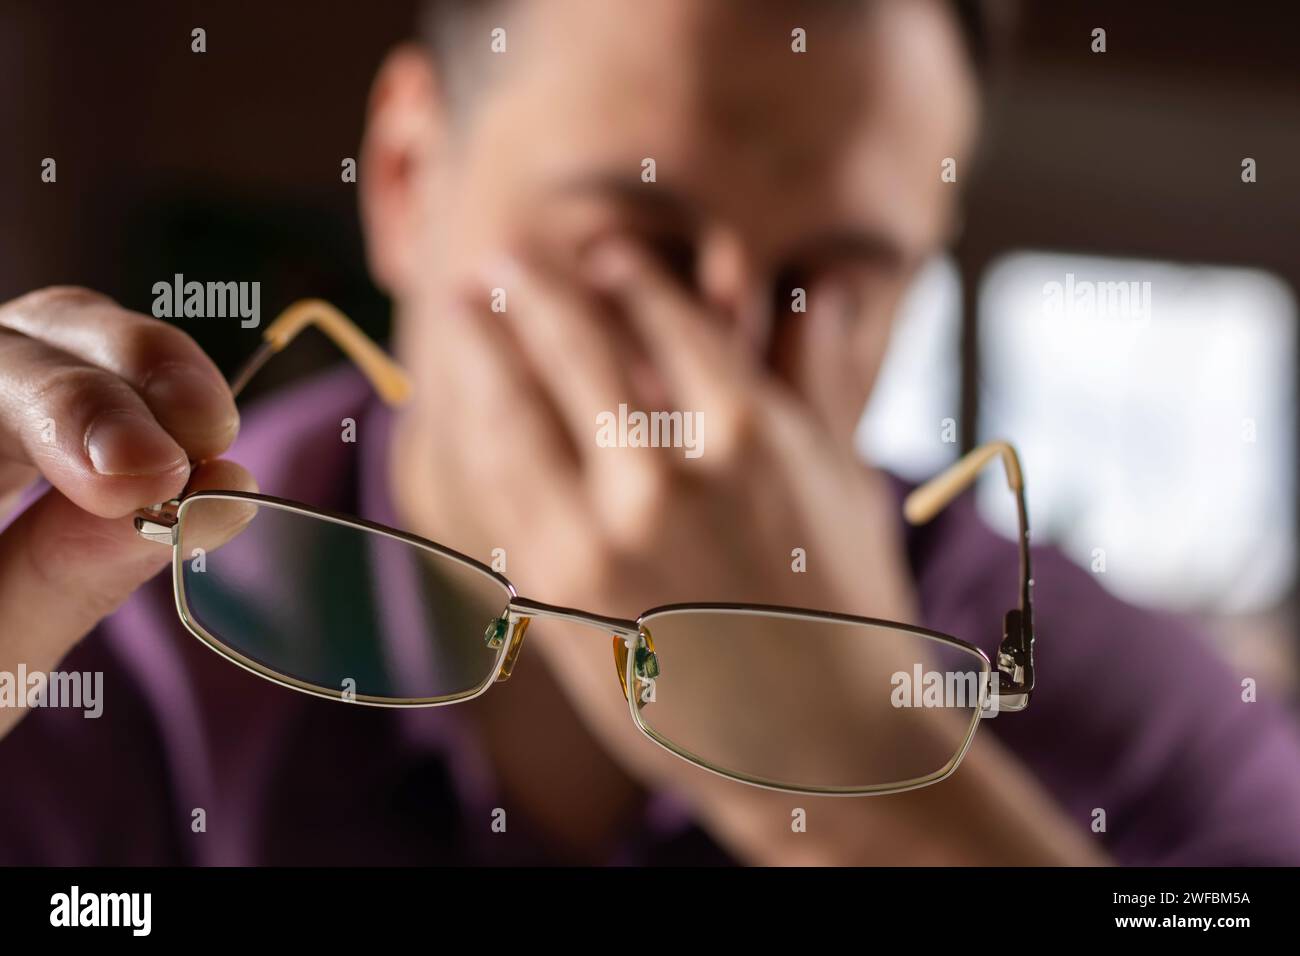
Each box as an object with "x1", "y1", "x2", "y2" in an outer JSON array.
[{"x1": 465, "y1": 0, "x2": 975, "y2": 254}]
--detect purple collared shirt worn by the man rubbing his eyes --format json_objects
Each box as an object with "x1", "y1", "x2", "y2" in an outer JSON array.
[{"x1": 0, "y1": 369, "x2": 1300, "y2": 865}]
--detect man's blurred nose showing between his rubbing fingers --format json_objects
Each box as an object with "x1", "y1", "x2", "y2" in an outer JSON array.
[{"x1": 696, "y1": 226, "x2": 772, "y2": 356}]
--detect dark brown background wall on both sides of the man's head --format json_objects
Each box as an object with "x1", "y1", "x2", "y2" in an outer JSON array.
[{"x1": 0, "y1": 0, "x2": 1300, "y2": 392}]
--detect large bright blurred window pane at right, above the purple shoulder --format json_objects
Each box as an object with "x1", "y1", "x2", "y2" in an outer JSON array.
[{"x1": 978, "y1": 252, "x2": 1296, "y2": 613}]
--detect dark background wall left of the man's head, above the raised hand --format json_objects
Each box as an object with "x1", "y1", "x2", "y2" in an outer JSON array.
[{"x1": 0, "y1": 0, "x2": 416, "y2": 386}]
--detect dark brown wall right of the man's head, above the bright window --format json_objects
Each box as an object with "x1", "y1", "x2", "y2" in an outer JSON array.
[{"x1": 958, "y1": 0, "x2": 1300, "y2": 434}]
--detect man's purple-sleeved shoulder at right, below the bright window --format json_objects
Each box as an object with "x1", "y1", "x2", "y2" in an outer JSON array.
[{"x1": 909, "y1": 478, "x2": 1300, "y2": 865}]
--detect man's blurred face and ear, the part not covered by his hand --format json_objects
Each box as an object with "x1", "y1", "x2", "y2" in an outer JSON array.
[{"x1": 367, "y1": 0, "x2": 976, "y2": 442}]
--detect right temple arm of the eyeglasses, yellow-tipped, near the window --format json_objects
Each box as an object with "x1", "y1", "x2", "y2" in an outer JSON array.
[{"x1": 902, "y1": 441, "x2": 1034, "y2": 711}]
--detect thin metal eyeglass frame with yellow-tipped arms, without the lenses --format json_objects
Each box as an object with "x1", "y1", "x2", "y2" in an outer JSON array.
[{"x1": 135, "y1": 299, "x2": 1035, "y2": 796}]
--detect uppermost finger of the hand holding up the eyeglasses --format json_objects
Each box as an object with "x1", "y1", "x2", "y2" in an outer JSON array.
[{"x1": 0, "y1": 287, "x2": 239, "y2": 460}]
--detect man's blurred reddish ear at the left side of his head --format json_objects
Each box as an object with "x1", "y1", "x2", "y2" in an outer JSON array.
[{"x1": 358, "y1": 44, "x2": 446, "y2": 295}]
